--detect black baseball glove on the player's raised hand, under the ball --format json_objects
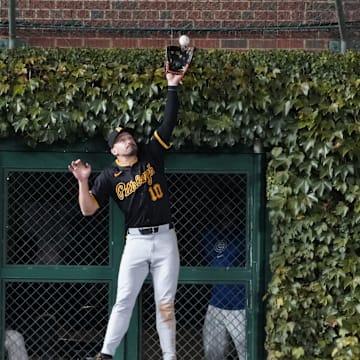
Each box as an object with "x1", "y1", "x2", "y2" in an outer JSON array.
[{"x1": 165, "y1": 45, "x2": 195, "y2": 75}]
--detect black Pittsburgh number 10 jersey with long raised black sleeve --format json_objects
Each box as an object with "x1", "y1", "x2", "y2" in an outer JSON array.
[{"x1": 91, "y1": 86, "x2": 179, "y2": 228}]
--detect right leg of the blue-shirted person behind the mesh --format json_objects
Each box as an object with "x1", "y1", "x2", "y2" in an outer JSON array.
[{"x1": 225, "y1": 310, "x2": 247, "y2": 360}]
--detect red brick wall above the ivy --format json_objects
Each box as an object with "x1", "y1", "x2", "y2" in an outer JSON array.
[{"x1": 0, "y1": 0, "x2": 360, "y2": 50}]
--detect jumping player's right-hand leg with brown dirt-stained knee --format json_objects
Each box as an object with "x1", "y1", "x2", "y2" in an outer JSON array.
[{"x1": 151, "y1": 229, "x2": 180, "y2": 360}]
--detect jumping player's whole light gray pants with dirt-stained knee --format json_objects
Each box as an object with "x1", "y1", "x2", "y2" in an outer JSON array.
[{"x1": 101, "y1": 225, "x2": 180, "y2": 360}]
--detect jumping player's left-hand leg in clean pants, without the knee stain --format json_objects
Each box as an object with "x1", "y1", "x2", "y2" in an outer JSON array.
[{"x1": 101, "y1": 235, "x2": 152, "y2": 356}]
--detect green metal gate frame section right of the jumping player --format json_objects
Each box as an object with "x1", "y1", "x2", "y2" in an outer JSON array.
[{"x1": 167, "y1": 153, "x2": 265, "y2": 359}]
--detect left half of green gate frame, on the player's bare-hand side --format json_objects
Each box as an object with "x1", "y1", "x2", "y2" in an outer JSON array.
[{"x1": 0, "y1": 151, "x2": 124, "y2": 359}]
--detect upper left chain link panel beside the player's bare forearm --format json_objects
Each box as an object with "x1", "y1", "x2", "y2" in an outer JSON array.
[{"x1": 6, "y1": 171, "x2": 109, "y2": 265}]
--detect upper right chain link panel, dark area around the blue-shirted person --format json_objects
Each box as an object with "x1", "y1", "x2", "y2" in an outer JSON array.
[{"x1": 168, "y1": 173, "x2": 247, "y2": 266}]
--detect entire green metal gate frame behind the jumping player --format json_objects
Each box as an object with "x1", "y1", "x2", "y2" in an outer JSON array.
[{"x1": 0, "y1": 144, "x2": 268, "y2": 360}]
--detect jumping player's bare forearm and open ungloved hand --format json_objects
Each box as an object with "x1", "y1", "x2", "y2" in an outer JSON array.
[{"x1": 68, "y1": 159, "x2": 98, "y2": 216}]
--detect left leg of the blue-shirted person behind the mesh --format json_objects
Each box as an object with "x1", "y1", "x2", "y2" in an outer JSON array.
[{"x1": 203, "y1": 305, "x2": 229, "y2": 360}]
